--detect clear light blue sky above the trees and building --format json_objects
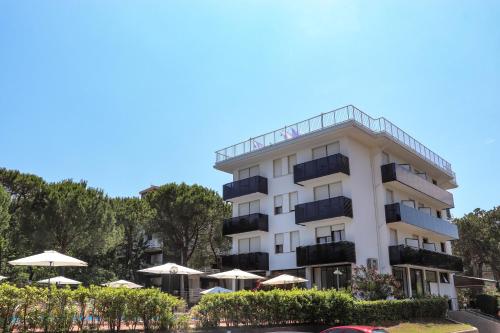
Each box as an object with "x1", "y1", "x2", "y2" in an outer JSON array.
[{"x1": 0, "y1": 0, "x2": 500, "y2": 216}]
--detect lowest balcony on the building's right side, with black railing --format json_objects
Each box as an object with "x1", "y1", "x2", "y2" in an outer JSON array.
[{"x1": 389, "y1": 245, "x2": 463, "y2": 272}]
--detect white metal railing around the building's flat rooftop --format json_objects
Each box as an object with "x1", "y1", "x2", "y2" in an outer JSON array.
[{"x1": 215, "y1": 105, "x2": 455, "y2": 177}]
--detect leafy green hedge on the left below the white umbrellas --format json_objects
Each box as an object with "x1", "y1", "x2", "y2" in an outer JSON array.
[{"x1": 0, "y1": 284, "x2": 185, "y2": 332}]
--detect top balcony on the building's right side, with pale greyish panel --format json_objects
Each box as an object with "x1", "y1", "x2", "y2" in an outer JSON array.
[{"x1": 381, "y1": 163, "x2": 454, "y2": 209}]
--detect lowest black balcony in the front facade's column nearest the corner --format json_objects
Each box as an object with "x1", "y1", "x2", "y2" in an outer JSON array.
[{"x1": 297, "y1": 241, "x2": 356, "y2": 267}]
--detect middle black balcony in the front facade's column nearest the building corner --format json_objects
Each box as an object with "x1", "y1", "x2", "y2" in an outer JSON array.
[{"x1": 295, "y1": 196, "x2": 352, "y2": 224}]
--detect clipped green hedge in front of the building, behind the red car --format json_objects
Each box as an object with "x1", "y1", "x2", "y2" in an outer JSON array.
[{"x1": 192, "y1": 289, "x2": 448, "y2": 327}]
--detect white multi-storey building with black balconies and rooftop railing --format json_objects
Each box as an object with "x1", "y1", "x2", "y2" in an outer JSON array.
[{"x1": 215, "y1": 106, "x2": 462, "y2": 303}]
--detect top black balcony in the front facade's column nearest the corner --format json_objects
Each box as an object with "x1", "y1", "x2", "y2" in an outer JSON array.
[{"x1": 293, "y1": 154, "x2": 349, "y2": 183}]
